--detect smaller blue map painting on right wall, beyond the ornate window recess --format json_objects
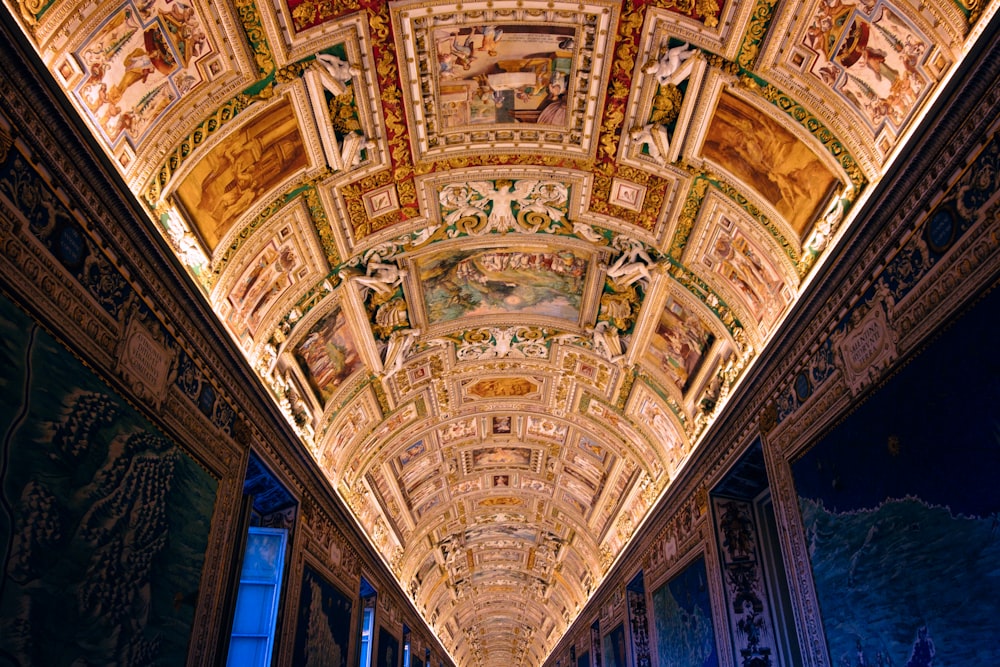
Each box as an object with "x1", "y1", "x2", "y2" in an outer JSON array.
[{"x1": 653, "y1": 558, "x2": 719, "y2": 667}]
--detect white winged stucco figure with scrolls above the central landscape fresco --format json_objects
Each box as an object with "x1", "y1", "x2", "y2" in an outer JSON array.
[{"x1": 438, "y1": 179, "x2": 569, "y2": 236}]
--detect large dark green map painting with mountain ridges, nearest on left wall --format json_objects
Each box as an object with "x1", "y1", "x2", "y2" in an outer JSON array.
[{"x1": 0, "y1": 297, "x2": 218, "y2": 666}]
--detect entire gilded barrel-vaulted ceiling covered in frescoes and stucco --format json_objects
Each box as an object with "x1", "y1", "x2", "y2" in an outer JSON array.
[{"x1": 6, "y1": 0, "x2": 997, "y2": 666}]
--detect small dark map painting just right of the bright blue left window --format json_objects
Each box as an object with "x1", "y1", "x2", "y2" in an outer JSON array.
[{"x1": 292, "y1": 565, "x2": 352, "y2": 667}]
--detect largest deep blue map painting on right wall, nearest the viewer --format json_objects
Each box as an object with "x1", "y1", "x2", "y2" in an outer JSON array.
[{"x1": 792, "y1": 290, "x2": 1000, "y2": 667}]
